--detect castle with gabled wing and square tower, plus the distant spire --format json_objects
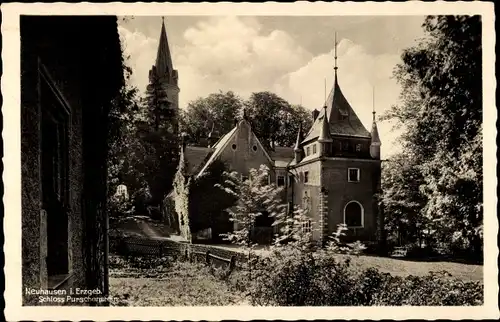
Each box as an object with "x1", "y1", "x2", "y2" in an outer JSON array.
[{"x1": 159, "y1": 20, "x2": 382, "y2": 243}]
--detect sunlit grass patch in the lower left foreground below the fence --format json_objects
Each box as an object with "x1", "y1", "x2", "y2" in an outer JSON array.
[{"x1": 109, "y1": 262, "x2": 248, "y2": 306}]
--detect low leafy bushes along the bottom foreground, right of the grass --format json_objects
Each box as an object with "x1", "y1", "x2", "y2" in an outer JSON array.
[{"x1": 228, "y1": 249, "x2": 484, "y2": 306}]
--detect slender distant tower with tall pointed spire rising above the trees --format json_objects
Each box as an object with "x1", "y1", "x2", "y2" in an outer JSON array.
[{"x1": 147, "y1": 18, "x2": 180, "y2": 134}]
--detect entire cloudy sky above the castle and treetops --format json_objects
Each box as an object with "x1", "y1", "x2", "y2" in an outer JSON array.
[{"x1": 118, "y1": 16, "x2": 424, "y2": 158}]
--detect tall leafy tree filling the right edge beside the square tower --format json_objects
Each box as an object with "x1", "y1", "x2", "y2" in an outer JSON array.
[{"x1": 385, "y1": 16, "x2": 483, "y2": 255}]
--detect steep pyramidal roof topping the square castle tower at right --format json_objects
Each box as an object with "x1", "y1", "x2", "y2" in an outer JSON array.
[{"x1": 302, "y1": 75, "x2": 370, "y2": 142}]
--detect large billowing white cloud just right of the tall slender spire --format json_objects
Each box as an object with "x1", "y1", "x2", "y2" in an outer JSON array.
[{"x1": 174, "y1": 16, "x2": 312, "y2": 103}]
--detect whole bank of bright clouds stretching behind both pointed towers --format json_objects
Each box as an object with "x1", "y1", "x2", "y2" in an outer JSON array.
[{"x1": 119, "y1": 16, "x2": 399, "y2": 156}]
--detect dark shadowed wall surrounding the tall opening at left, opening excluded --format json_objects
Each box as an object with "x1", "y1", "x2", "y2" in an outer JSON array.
[{"x1": 20, "y1": 16, "x2": 123, "y2": 305}]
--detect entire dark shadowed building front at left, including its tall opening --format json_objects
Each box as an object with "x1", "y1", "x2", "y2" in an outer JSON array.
[{"x1": 20, "y1": 16, "x2": 123, "y2": 305}]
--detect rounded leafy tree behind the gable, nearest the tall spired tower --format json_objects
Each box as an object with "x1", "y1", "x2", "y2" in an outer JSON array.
[{"x1": 181, "y1": 91, "x2": 243, "y2": 145}]
